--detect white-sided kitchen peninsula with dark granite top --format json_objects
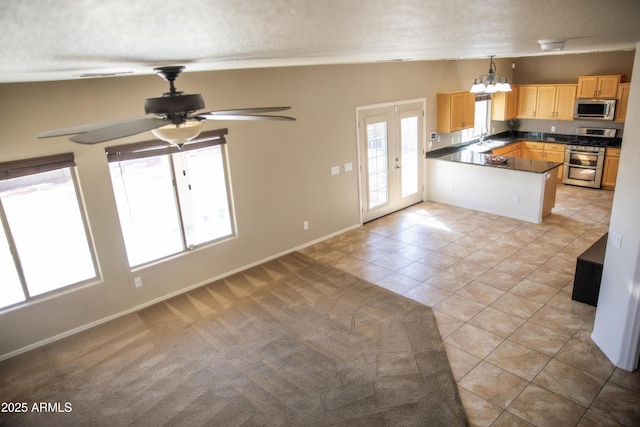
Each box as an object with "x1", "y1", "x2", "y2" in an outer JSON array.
[{"x1": 427, "y1": 142, "x2": 562, "y2": 223}]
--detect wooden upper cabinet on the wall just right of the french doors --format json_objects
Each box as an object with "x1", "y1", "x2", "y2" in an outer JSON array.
[{"x1": 436, "y1": 91, "x2": 476, "y2": 133}]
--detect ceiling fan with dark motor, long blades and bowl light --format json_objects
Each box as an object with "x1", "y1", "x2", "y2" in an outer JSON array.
[{"x1": 36, "y1": 65, "x2": 295, "y2": 146}]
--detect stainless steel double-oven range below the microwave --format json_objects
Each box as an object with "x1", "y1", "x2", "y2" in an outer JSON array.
[{"x1": 562, "y1": 128, "x2": 616, "y2": 188}]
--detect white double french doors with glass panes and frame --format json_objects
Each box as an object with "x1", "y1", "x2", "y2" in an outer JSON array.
[{"x1": 356, "y1": 100, "x2": 426, "y2": 222}]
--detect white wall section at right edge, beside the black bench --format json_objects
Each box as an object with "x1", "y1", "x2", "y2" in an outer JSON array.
[{"x1": 591, "y1": 44, "x2": 640, "y2": 371}]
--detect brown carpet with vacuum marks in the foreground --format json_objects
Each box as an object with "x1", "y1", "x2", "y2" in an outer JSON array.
[{"x1": 0, "y1": 252, "x2": 467, "y2": 426}]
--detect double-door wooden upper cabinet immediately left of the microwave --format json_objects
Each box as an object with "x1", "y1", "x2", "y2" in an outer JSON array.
[{"x1": 517, "y1": 85, "x2": 577, "y2": 120}]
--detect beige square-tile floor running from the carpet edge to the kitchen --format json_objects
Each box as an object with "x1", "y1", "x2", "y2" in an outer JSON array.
[{"x1": 303, "y1": 184, "x2": 640, "y2": 426}]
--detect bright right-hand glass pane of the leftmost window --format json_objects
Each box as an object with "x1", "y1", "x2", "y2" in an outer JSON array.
[{"x1": 0, "y1": 168, "x2": 96, "y2": 296}]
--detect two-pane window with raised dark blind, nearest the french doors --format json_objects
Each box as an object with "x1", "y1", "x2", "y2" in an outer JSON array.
[{"x1": 107, "y1": 130, "x2": 234, "y2": 267}]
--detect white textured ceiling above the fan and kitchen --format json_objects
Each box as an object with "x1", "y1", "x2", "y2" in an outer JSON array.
[{"x1": 0, "y1": 0, "x2": 640, "y2": 83}]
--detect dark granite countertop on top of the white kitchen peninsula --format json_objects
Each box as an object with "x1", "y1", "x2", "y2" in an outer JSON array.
[{"x1": 432, "y1": 150, "x2": 562, "y2": 173}]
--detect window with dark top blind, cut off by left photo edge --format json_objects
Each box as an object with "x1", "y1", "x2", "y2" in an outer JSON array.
[{"x1": 0, "y1": 153, "x2": 96, "y2": 308}]
